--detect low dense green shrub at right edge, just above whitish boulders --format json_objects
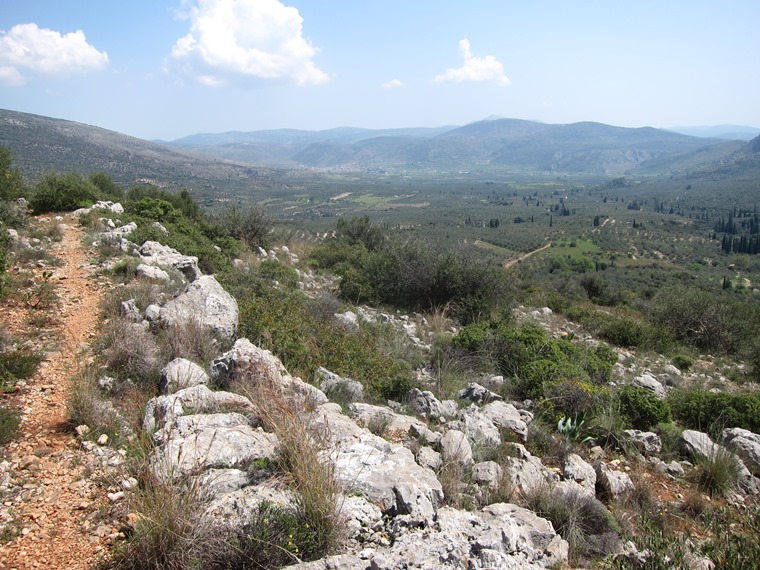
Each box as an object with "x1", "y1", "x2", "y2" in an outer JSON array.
[{"x1": 668, "y1": 389, "x2": 760, "y2": 435}]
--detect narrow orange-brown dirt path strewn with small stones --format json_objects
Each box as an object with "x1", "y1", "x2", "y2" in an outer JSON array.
[{"x1": 0, "y1": 217, "x2": 114, "y2": 570}]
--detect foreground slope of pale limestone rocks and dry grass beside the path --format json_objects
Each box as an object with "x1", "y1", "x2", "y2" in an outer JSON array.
[{"x1": 2, "y1": 196, "x2": 760, "y2": 570}]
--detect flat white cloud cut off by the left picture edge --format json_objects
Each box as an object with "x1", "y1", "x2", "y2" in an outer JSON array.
[{"x1": 0, "y1": 24, "x2": 108, "y2": 86}]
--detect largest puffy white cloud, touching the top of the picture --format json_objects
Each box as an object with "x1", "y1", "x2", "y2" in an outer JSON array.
[{"x1": 172, "y1": 0, "x2": 329, "y2": 85}]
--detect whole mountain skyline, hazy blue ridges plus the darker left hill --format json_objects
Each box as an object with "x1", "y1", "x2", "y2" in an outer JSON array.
[{"x1": 0, "y1": 110, "x2": 760, "y2": 191}]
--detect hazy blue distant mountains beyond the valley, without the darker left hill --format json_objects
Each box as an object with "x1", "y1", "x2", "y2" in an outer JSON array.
[{"x1": 166, "y1": 118, "x2": 760, "y2": 175}]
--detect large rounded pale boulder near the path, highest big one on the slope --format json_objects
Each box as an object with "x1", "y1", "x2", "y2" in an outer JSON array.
[{"x1": 160, "y1": 275, "x2": 238, "y2": 339}]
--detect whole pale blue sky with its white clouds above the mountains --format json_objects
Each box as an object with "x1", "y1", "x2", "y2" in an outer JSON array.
[{"x1": 0, "y1": 0, "x2": 760, "y2": 140}]
